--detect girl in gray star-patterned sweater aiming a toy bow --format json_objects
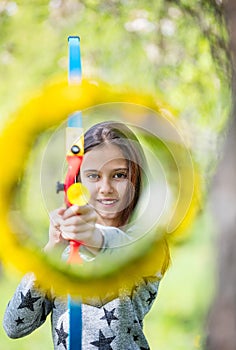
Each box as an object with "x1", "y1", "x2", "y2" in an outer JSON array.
[{"x1": 4, "y1": 122, "x2": 169, "y2": 350}]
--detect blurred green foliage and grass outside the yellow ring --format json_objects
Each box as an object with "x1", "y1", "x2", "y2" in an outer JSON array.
[{"x1": 0, "y1": 0, "x2": 230, "y2": 350}]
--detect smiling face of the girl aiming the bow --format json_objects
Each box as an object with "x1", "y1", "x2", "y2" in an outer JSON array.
[{"x1": 80, "y1": 144, "x2": 130, "y2": 226}]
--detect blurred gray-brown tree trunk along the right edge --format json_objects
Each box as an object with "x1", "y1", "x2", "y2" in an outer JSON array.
[{"x1": 206, "y1": 0, "x2": 236, "y2": 350}]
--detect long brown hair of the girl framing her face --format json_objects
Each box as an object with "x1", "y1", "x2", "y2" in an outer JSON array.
[{"x1": 84, "y1": 121, "x2": 146, "y2": 227}]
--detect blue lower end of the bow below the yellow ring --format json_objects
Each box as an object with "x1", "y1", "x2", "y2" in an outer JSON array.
[{"x1": 68, "y1": 296, "x2": 82, "y2": 350}]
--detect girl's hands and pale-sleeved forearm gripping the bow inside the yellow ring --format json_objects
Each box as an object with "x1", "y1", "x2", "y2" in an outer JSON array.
[{"x1": 44, "y1": 205, "x2": 135, "y2": 257}]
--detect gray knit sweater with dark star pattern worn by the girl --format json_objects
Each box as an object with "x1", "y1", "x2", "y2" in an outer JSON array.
[{"x1": 3, "y1": 228, "x2": 160, "y2": 350}]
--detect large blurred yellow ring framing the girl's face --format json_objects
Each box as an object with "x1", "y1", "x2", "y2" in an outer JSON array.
[{"x1": 0, "y1": 79, "x2": 200, "y2": 298}]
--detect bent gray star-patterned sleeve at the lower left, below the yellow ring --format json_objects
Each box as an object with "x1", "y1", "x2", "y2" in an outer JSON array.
[{"x1": 3, "y1": 273, "x2": 52, "y2": 339}]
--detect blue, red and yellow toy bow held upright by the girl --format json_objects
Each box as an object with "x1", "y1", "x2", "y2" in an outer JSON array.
[{"x1": 57, "y1": 36, "x2": 85, "y2": 350}]
